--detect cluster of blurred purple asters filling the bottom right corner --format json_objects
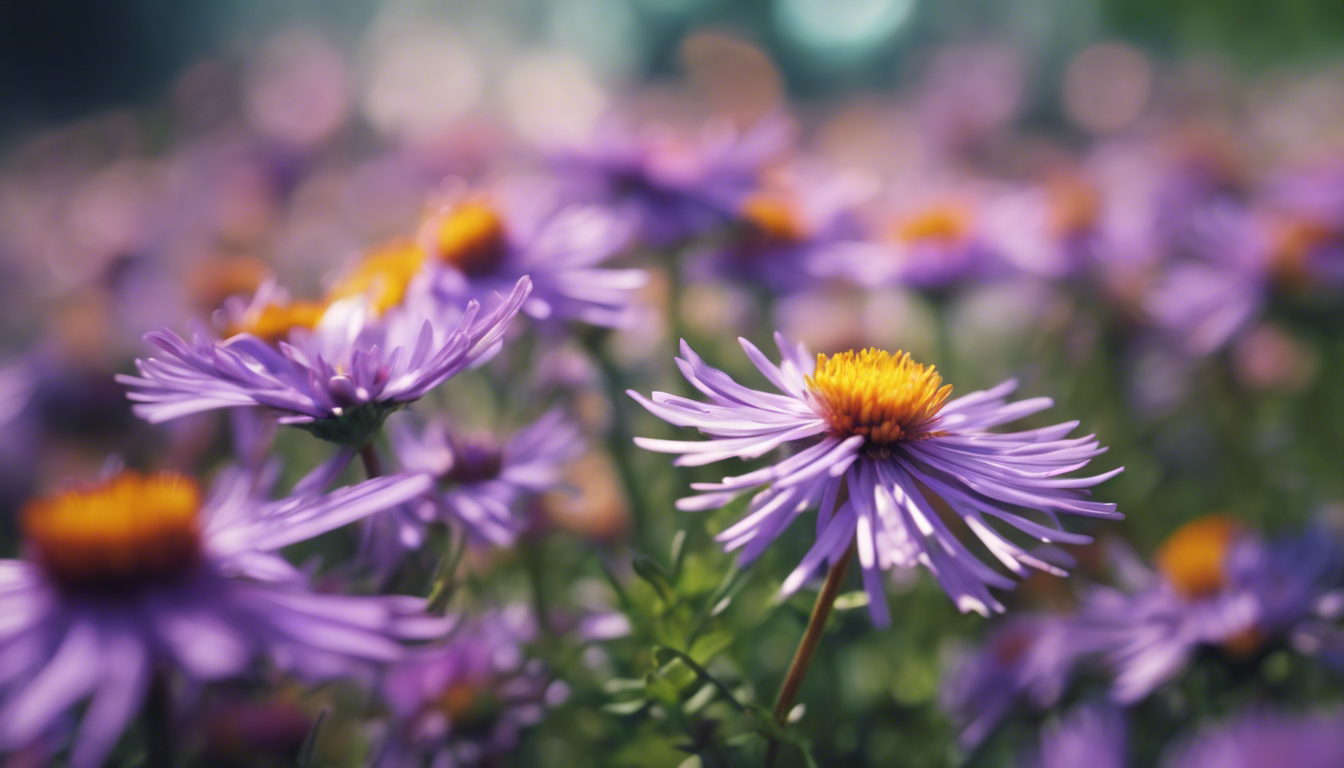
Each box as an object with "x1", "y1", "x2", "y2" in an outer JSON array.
[{"x1": 943, "y1": 515, "x2": 1344, "y2": 768}]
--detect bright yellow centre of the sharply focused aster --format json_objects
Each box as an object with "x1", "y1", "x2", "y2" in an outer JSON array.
[{"x1": 806, "y1": 347, "x2": 952, "y2": 445}]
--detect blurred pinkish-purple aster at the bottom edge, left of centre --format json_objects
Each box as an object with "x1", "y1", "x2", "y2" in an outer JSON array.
[{"x1": 374, "y1": 605, "x2": 567, "y2": 768}]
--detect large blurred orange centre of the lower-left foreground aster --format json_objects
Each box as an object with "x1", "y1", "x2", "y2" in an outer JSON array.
[{"x1": 19, "y1": 472, "x2": 202, "y2": 592}]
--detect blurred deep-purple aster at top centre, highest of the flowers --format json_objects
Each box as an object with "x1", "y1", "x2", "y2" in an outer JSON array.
[{"x1": 555, "y1": 117, "x2": 793, "y2": 246}]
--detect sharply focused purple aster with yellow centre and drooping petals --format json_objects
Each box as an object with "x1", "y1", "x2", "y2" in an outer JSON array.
[{"x1": 630, "y1": 335, "x2": 1120, "y2": 624}]
